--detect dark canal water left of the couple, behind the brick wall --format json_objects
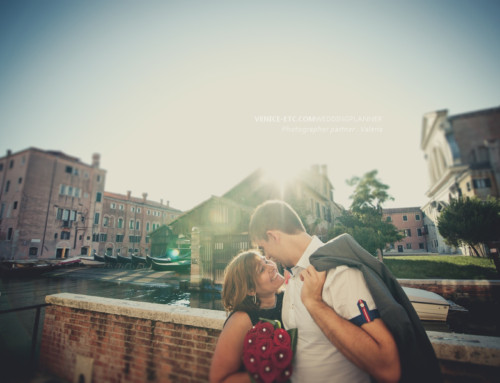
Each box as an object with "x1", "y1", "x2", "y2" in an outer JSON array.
[{"x1": 0, "y1": 275, "x2": 223, "y2": 382}]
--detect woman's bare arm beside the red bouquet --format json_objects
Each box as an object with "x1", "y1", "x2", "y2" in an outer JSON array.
[{"x1": 210, "y1": 311, "x2": 252, "y2": 383}]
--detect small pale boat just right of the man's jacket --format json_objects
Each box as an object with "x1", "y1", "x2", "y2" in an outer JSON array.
[{"x1": 403, "y1": 287, "x2": 450, "y2": 322}]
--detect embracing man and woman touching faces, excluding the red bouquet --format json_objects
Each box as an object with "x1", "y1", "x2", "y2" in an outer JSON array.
[{"x1": 210, "y1": 201, "x2": 442, "y2": 383}]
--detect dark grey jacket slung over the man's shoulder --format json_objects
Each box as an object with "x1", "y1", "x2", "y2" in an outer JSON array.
[{"x1": 309, "y1": 234, "x2": 443, "y2": 383}]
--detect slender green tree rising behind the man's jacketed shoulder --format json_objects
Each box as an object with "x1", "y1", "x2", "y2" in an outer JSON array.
[{"x1": 329, "y1": 170, "x2": 403, "y2": 260}]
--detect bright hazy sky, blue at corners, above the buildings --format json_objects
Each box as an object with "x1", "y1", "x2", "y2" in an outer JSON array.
[{"x1": 0, "y1": 0, "x2": 500, "y2": 210}]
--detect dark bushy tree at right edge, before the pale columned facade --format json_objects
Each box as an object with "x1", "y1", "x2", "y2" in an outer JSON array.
[{"x1": 438, "y1": 198, "x2": 500, "y2": 273}]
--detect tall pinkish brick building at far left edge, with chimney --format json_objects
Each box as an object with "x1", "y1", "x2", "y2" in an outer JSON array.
[{"x1": 0, "y1": 148, "x2": 106, "y2": 259}]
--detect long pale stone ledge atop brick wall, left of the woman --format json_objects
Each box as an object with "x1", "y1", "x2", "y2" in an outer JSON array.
[{"x1": 45, "y1": 293, "x2": 226, "y2": 330}]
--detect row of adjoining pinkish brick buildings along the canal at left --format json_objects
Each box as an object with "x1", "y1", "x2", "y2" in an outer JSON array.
[{"x1": 0, "y1": 148, "x2": 181, "y2": 260}]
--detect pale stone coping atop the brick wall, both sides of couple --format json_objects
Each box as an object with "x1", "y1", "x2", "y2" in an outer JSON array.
[{"x1": 45, "y1": 293, "x2": 500, "y2": 367}]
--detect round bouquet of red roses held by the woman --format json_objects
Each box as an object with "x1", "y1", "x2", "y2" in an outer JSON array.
[{"x1": 243, "y1": 318, "x2": 297, "y2": 383}]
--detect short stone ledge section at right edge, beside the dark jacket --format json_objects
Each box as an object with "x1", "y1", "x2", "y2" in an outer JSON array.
[{"x1": 427, "y1": 331, "x2": 500, "y2": 367}]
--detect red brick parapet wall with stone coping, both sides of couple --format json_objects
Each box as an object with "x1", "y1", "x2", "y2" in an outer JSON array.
[{"x1": 39, "y1": 293, "x2": 500, "y2": 383}]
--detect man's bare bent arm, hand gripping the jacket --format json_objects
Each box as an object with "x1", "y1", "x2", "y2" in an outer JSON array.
[{"x1": 300, "y1": 266, "x2": 401, "y2": 382}]
